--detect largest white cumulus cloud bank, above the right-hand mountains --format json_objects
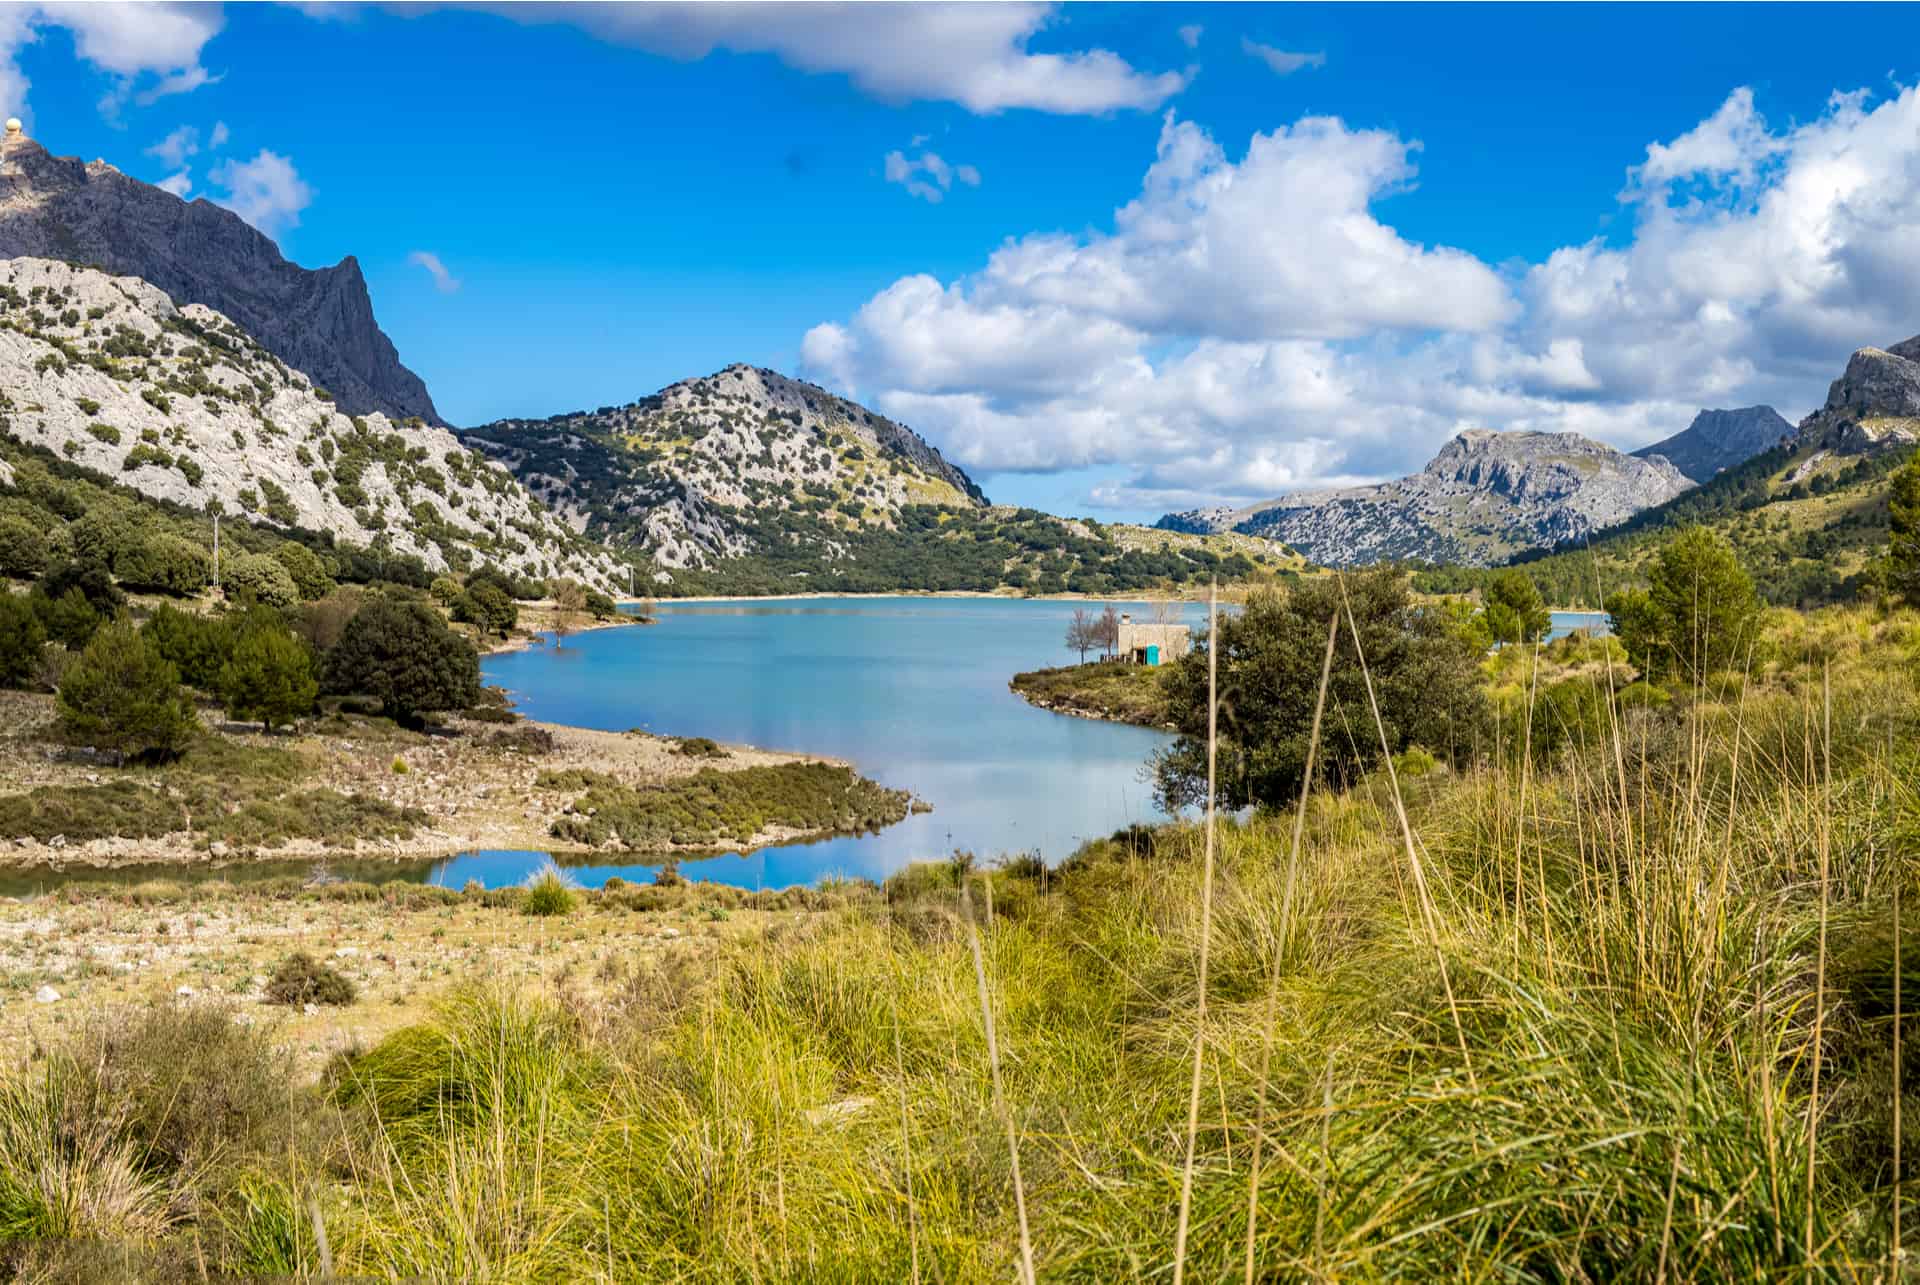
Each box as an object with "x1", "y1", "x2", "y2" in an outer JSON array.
[{"x1": 801, "y1": 80, "x2": 1920, "y2": 507}]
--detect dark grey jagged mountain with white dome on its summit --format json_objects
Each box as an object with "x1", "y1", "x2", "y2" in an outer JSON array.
[{"x1": 0, "y1": 121, "x2": 442, "y2": 424}]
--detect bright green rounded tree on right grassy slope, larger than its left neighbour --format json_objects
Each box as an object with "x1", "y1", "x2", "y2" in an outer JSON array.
[{"x1": 1607, "y1": 526, "x2": 1761, "y2": 682}]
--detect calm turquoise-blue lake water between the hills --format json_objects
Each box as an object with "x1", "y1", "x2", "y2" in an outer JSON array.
[{"x1": 430, "y1": 597, "x2": 1605, "y2": 887}]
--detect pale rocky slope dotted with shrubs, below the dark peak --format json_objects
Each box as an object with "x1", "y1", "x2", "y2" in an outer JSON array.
[{"x1": 0, "y1": 257, "x2": 626, "y2": 588}]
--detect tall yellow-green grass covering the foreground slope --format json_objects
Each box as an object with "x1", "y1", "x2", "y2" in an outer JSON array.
[{"x1": 0, "y1": 611, "x2": 1920, "y2": 1281}]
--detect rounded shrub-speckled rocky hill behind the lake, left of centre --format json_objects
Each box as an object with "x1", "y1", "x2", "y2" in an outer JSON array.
[{"x1": 463, "y1": 365, "x2": 987, "y2": 569}]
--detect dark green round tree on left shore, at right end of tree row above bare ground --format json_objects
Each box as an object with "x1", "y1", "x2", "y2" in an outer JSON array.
[{"x1": 326, "y1": 597, "x2": 480, "y2": 724}]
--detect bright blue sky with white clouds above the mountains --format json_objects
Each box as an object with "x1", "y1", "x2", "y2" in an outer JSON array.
[{"x1": 11, "y1": 4, "x2": 1920, "y2": 519}]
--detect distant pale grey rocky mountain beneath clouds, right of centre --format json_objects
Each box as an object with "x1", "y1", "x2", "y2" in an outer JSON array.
[{"x1": 1160, "y1": 428, "x2": 1692, "y2": 567}]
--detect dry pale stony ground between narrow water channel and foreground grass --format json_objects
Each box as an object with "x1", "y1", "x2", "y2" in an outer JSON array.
[{"x1": 0, "y1": 884, "x2": 810, "y2": 1074}]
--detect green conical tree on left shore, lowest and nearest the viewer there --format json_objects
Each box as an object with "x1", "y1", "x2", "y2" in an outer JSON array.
[{"x1": 56, "y1": 622, "x2": 200, "y2": 759}]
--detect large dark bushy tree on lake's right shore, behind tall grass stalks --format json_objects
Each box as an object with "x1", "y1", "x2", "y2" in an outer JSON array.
[{"x1": 1154, "y1": 567, "x2": 1490, "y2": 807}]
